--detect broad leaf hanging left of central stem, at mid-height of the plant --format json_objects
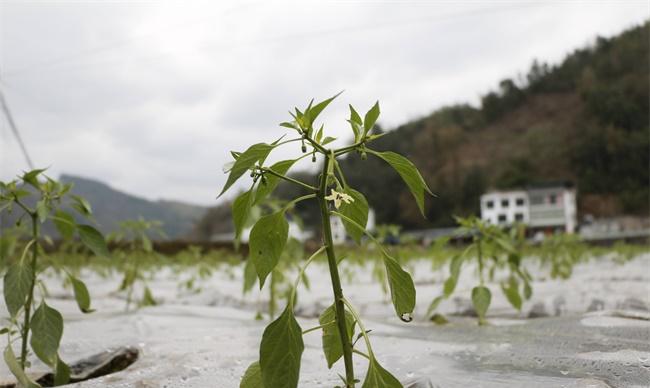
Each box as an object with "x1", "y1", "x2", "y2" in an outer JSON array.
[{"x1": 249, "y1": 211, "x2": 289, "y2": 288}]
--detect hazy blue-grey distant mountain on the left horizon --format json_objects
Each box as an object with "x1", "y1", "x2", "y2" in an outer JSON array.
[{"x1": 60, "y1": 174, "x2": 207, "y2": 239}]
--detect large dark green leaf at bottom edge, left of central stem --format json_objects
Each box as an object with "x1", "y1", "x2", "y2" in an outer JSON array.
[{"x1": 260, "y1": 306, "x2": 305, "y2": 388}]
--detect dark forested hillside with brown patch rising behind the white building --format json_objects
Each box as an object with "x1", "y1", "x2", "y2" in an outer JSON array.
[{"x1": 342, "y1": 23, "x2": 650, "y2": 228}]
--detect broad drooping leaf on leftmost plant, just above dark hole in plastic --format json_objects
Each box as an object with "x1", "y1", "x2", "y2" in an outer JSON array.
[{"x1": 30, "y1": 301, "x2": 63, "y2": 368}]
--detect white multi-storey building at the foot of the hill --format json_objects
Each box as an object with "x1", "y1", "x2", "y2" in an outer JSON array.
[{"x1": 481, "y1": 185, "x2": 577, "y2": 233}]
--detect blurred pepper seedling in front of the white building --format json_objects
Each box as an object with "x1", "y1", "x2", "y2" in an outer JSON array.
[{"x1": 427, "y1": 217, "x2": 533, "y2": 325}]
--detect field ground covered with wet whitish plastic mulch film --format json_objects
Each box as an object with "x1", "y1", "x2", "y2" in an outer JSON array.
[{"x1": 0, "y1": 248, "x2": 650, "y2": 388}]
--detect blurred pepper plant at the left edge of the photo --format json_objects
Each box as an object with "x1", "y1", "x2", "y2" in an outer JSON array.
[{"x1": 0, "y1": 169, "x2": 109, "y2": 388}]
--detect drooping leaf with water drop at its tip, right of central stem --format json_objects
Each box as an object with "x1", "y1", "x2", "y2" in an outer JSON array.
[{"x1": 383, "y1": 252, "x2": 415, "y2": 322}]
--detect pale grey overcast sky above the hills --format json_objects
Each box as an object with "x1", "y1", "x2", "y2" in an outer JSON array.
[{"x1": 0, "y1": 0, "x2": 650, "y2": 205}]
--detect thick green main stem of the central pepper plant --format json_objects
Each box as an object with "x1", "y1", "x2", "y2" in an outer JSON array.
[{"x1": 318, "y1": 153, "x2": 354, "y2": 388}]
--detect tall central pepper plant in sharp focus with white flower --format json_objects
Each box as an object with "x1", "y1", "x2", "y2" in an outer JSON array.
[{"x1": 219, "y1": 95, "x2": 431, "y2": 388}]
